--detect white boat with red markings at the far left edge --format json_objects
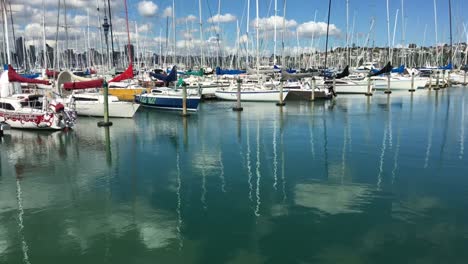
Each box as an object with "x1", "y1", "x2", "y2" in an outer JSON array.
[{"x1": 0, "y1": 94, "x2": 76, "y2": 130}]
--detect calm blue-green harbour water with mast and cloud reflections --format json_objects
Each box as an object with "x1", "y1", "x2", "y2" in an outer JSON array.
[{"x1": 0, "y1": 88, "x2": 468, "y2": 264}]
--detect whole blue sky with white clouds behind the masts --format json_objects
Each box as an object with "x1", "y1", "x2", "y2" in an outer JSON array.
[{"x1": 4, "y1": 0, "x2": 468, "y2": 54}]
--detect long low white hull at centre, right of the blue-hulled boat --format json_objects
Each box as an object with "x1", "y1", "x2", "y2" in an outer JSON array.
[{"x1": 215, "y1": 90, "x2": 289, "y2": 102}]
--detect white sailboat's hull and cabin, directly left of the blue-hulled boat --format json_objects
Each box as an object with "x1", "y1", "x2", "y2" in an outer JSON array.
[{"x1": 68, "y1": 93, "x2": 140, "y2": 118}]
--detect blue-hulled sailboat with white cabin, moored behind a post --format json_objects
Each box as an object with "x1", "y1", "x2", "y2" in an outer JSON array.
[{"x1": 135, "y1": 87, "x2": 200, "y2": 111}]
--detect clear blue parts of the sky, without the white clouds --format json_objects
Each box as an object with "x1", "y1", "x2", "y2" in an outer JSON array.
[{"x1": 122, "y1": 0, "x2": 468, "y2": 50}]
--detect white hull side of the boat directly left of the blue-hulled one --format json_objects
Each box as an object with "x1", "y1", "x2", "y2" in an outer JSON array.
[{"x1": 75, "y1": 101, "x2": 140, "y2": 118}]
